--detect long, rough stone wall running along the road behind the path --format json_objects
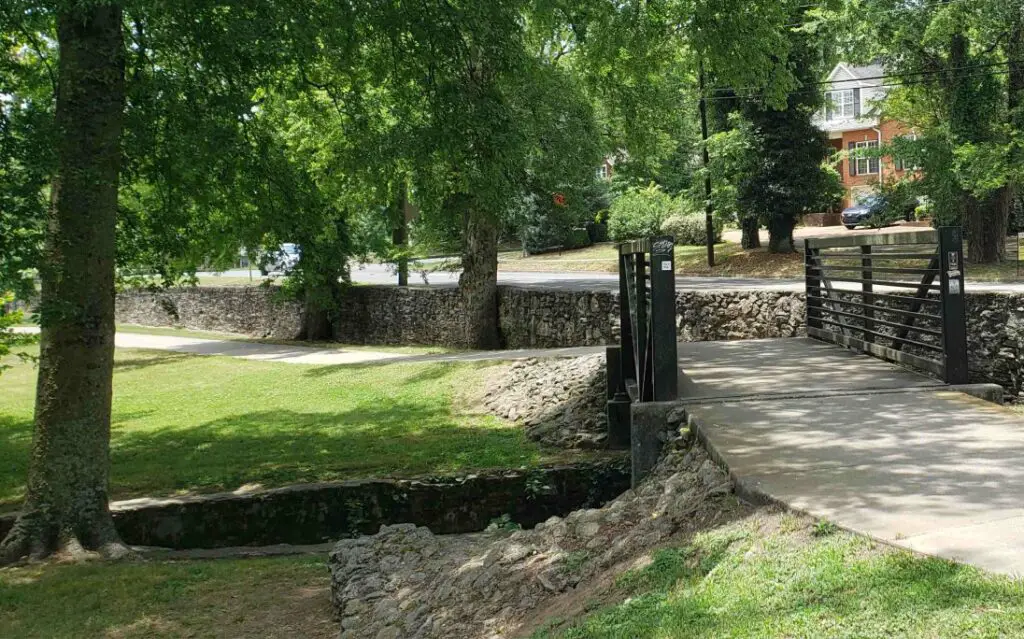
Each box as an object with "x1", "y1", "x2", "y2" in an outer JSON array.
[{"x1": 118, "y1": 286, "x2": 1024, "y2": 396}]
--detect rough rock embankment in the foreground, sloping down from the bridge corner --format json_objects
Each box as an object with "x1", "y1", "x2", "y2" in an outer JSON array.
[{"x1": 330, "y1": 425, "x2": 735, "y2": 639}]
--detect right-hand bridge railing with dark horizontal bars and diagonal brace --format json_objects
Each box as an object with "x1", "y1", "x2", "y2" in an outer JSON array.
[{"x1": 804, "y1": 227, "x2": 968, "y2": 384}]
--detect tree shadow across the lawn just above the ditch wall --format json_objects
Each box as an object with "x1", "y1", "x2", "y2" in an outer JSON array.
[{"x1": 101, "y1": 402, "x2": 542, "y2": 499}]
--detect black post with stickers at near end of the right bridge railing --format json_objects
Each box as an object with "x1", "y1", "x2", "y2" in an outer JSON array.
[{"x1": 938, "y1": 226, "x2": 968, "y2": 384}]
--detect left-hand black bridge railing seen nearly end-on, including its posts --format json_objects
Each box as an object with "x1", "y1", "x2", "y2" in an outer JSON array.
[{"x1": 607, "y1": 237, "x2": 679, "y2": 445}]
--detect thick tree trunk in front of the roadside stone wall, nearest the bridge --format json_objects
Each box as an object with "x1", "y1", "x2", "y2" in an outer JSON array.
[{"x1": 459, "y1": 205, "x2": 501, "y2": 349}]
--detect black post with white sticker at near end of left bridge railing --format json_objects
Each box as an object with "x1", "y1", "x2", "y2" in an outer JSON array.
[{"x1": 650, "y1": 237, "x2": 679, "y2": 401}]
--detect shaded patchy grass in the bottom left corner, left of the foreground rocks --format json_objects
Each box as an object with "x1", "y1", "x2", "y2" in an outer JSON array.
[{"x1": 0, "y1": 557, "x2": 338, "y2": 639}]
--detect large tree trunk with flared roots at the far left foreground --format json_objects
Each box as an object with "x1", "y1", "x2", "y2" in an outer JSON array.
[{"x1": 0, "y1": 3, "x2": 127, "y2": 562}]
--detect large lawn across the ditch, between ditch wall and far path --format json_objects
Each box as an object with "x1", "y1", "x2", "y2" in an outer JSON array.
[{"x1": 0, "y1": 350, "x2": 568, "y2": 510}]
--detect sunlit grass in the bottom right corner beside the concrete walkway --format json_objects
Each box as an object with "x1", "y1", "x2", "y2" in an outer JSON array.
[{"x1": 534, "y1": 514, "x2": 1024, "y2": 639}]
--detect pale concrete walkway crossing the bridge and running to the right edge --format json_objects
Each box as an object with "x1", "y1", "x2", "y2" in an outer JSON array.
[{"x1": 681, "y1": 339, "x2": 1024, "y2": 576}]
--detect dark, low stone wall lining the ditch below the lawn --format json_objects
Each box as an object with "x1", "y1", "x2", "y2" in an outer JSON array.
[{"x1": 0, "y1": 456, "x2": 630, "y2": 549}]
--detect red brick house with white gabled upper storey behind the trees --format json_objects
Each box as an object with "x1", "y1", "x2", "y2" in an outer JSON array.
[{"x1": 815, "y1": 62, "x2": 914, "y2": 206}]
